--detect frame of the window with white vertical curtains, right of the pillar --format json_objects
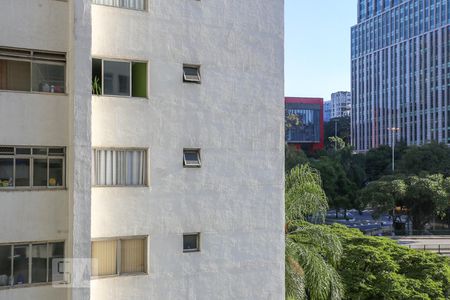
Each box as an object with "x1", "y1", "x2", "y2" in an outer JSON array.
[{"x1": 92, "y1": 147, "x2": 150, "y2": 188}]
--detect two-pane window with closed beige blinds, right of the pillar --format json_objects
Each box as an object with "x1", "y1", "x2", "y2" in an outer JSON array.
[{"x1": 91, "y1": 237, "x2": 147, "y2": 277}]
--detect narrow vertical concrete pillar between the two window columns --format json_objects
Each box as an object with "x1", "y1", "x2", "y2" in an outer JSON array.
[{"x1": 66, "y1": 0, "x2": 92, "y2": 300}]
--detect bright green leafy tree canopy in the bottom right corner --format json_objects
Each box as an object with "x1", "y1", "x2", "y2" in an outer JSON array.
[{"x1": 331, "y1": 224, "x2": 450, "y2": 300}]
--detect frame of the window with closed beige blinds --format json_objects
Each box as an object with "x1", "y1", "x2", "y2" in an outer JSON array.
[{"x1": 91, "y1": 235, "x2": 150, "y2": 279}]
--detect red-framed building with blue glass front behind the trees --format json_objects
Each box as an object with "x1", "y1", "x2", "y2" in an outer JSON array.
[{"x1": 285, "y1": 97, "x2": 324, "y2": 152}]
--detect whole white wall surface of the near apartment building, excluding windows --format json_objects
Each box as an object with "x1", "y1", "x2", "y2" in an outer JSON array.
[{"x1": 0, "y1": 0, "x2": 284, "y2": 300}]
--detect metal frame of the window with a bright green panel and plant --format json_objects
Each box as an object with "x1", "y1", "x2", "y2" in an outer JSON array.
[{"x1": 91, "y1": 56, "x2": 150, "y2": 99}]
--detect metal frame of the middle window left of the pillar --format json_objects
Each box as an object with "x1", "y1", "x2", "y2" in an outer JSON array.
[{"x1": 0, "y1": 145, "x2": 67, "y2": 191}]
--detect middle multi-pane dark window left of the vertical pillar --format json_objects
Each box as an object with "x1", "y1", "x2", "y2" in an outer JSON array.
[{"x1": 0, "y1": 146, "x2": 65, "y2": 189}]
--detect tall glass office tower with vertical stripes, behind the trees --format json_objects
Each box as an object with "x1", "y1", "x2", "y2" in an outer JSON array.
[{"x1": 351, "y1": 0, "x2": 450, "y2": 151}]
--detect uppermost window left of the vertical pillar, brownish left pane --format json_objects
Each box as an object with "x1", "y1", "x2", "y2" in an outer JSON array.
[{"x1": 0, "y1": 47, "x2": 66, "y2": 93}]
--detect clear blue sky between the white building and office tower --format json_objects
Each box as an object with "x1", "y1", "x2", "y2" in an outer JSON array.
[{"x1": 285, "y1": 0, "x2": 357, "y2": 100}]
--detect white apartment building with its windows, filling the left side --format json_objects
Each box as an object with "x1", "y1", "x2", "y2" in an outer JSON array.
[{"x1": 0, "y1": 0, "x2": 284, "y2": 300}]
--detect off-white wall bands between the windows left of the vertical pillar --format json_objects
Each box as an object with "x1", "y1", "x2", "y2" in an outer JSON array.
[{"x1": 0, "y1": 0, "x2": 69, "y2": 300}]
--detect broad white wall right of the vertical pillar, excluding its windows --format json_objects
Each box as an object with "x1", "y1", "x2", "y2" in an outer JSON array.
[{"x1": 91, "y1": 0, "x2": 284, "y2": 299}]
